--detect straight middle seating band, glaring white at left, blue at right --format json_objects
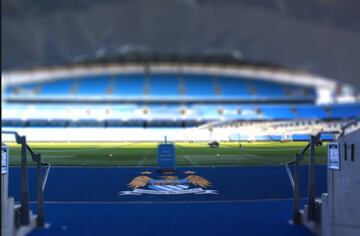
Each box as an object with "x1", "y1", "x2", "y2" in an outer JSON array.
[{"x1": 3, "y1": 104, "x2": 360, "y2": 120}]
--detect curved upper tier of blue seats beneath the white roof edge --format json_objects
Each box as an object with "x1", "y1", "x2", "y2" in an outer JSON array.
[{"x1": 5, "y1": 74, "x2": 315, "y2": 99}]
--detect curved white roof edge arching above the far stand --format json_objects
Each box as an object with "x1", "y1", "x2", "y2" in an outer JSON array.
[{"x1": 1, "y1": 63, "x2": 344, "y2": 103}]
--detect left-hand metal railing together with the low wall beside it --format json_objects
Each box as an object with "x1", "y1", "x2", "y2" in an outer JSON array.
[{"x1": 1, "y1": 131, "x2": 51, "y2": 235}]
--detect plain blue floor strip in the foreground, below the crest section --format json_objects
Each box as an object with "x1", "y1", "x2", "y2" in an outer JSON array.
[{"x1": 32, "y1": 200, "x2": 312, "y2": 236}]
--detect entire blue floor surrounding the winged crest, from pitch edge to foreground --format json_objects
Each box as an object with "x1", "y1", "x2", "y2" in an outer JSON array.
[{"x1": 10, "y1": 166, "x2": 326, "y2": 235}]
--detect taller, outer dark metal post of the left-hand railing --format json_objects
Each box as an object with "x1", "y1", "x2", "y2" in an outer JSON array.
[{"x1": 19, "y1": 136, "x2": 30, "y2": 225}]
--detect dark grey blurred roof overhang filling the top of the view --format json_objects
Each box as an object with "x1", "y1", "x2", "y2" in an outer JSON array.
[{"x1": 2, "y1": 0, "x2": 360, "y2": 90}]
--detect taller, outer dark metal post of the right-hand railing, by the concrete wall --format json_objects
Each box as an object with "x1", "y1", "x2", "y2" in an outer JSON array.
[{"x1": 307, "y1": 136, "x2": 316, "y2": 220}]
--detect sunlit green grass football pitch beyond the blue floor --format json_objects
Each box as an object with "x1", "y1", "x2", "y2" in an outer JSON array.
[{"x1": 7, "y1": 142, "x2": 326, "y2": 167}]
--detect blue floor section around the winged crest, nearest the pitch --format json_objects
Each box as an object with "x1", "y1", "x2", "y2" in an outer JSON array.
[{"x1": 9, "y1": 165, "x2": 326, "y2": 202}]
